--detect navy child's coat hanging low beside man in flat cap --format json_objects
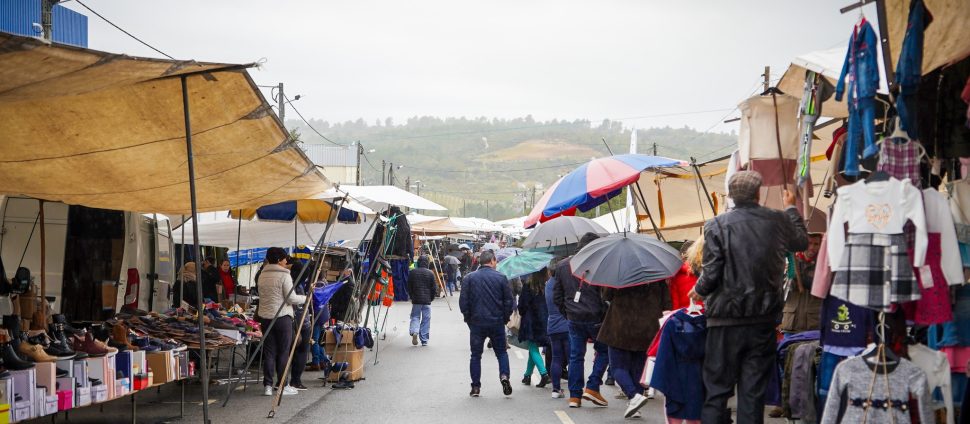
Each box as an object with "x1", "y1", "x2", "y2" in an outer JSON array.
[{"x1": 650, "y1": 309, "x2": 707, "y2": 420}]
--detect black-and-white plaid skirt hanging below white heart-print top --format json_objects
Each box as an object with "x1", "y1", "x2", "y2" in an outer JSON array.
[{"x1": 831, "y1": 234, "x2": 920, "y2": 312}]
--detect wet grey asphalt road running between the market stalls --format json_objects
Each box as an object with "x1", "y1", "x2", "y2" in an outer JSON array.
[{"x1": 37, "y1": 297, "x2": 782, "y2": 424}]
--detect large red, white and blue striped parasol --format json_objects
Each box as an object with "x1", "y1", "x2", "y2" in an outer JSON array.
[{"x1": 525, "y1": 154, "x2": 687, "y2": 228}]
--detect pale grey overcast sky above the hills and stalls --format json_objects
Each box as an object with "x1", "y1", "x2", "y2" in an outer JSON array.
[{"x1": 65, "y1": 0, "x2": 876, "y2": 131}]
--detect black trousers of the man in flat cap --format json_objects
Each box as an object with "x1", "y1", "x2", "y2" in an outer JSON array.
[{"x1": 701, "y1": 324, "x2": 776, "y2": 424}]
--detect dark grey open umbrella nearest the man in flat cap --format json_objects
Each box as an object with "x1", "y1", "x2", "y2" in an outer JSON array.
[{"x1": 569, "y1": 233, "x2": 683, "y2": 288}]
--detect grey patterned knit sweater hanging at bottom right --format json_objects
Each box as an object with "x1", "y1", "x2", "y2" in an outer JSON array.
[{"x1": 821, "y1": 357, "x2": 934, "y2": 424}]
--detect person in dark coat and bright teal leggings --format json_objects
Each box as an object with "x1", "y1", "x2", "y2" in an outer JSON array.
[{"x1": 519, "y1": 269, "x2": 549, "y2": 388}]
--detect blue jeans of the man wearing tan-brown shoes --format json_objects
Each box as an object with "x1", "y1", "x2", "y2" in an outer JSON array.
[{"x1": 569, "y1": 321, "x2": 610, "y2": 398}]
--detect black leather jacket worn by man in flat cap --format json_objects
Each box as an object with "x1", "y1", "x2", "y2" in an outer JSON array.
[{"x1": 694, "y1": 203, "x2": 808, "y2": 327}]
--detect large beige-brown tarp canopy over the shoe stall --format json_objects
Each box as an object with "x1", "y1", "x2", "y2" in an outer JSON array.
[{"x1": 0, "y1": 33, "x2": 329, "y2": 215}]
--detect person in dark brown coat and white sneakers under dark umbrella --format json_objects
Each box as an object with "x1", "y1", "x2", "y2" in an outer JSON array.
[{"x1": 596, "y1": 281, "x2": 671, "y2": 418}]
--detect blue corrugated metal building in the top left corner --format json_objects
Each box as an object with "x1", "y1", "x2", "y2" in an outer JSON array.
[{"x1": 0, "y1": 0, "x2": 88, "y2": 47}]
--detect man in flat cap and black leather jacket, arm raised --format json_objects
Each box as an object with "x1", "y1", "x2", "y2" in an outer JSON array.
[{"x1": 690, "y1": 171, "x2": 808, "y2": 424}]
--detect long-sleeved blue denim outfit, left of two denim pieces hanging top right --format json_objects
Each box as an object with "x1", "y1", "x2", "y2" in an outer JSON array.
[{"x1": 835, "y1": 18, "x2": 879, "y2": 176}]
